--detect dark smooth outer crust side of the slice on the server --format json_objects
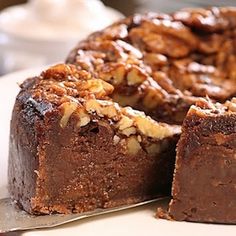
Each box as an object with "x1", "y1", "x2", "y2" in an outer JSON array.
[{"x1": 8, "y1": 78, "x2": 51, "y2": 212}]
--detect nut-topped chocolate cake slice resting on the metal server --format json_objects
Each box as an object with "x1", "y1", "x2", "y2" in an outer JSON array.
[{"x1": 8, "y1": 65, "x2": 180, "y2": 214}]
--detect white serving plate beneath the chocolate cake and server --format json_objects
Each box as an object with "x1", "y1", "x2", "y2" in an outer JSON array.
[{"x1": 0, "y1": 68, "x2": 236, "y2": 236}]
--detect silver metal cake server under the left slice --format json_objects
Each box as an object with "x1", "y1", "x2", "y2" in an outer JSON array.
[{"x1": 0, "y1": 197, "x2": 165, "y2": 233}]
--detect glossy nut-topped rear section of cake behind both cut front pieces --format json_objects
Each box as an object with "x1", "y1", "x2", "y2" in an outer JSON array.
[{"x1": 67, "y1": 7, "x2": 236, "y2": 124}]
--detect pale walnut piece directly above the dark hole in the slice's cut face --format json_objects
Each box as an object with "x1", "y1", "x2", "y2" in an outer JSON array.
[{"x1": 85, "y1": 99, "x2": 120, "y2": 120}]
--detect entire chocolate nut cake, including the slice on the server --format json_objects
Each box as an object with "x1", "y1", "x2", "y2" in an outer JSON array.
[{"x1": 9, "y1": 7, "x2": 236, "y2": 223}]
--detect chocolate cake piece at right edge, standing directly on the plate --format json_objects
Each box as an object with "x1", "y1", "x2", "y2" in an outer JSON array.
[{"x1": 169, "y1": 99, "x2": 236, "y2": 224}]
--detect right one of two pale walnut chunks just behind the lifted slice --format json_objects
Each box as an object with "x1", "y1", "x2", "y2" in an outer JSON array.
[{"x1": 127, "y1": 66, "x2": 148, "y2": 86}]
